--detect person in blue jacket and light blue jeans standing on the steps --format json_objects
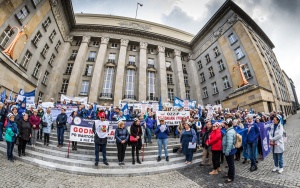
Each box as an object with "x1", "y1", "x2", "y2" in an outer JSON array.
[{"x1": 155, "y1": 118, "x2": 170, "y2": 162}]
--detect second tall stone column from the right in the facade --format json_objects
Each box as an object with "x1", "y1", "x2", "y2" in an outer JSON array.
[{"x1": 174, "y1": 49, "x2": 186, "y2": 99}]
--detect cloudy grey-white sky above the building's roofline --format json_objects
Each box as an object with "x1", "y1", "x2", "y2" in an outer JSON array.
[{"x1": 72, "y1": 0, "x2": 300, "y2": 101}]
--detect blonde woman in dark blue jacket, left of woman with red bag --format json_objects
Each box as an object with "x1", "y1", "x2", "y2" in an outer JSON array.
[{"x1": 115, "y1": 120, "x2": 129, "y2": 165}]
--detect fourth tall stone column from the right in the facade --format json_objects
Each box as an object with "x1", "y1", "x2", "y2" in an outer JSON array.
[{"x1": 138, "y1": 42, "x2": 148, "y2": 101}]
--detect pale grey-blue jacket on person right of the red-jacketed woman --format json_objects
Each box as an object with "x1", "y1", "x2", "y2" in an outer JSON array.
[{"x1": 222, "y1": 127, "x2": 236, "y2": 156}]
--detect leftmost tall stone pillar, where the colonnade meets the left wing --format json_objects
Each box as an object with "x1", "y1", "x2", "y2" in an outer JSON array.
[{"x1": 44, "y1": 36, "x2": 73, "y2": 101}]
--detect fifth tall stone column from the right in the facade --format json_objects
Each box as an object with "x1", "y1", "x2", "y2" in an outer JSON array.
[{"x1": 114, "y1": 39, "x2": 129, "y2": 105}]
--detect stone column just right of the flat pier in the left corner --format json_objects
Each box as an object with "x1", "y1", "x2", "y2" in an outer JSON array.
[{"x1": 67, "y1": 36, "x2": 91, "y2": 97}]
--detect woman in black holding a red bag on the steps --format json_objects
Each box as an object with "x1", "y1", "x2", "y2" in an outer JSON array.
[{"x1": 130, "y1": 118, "x2": 143, "y2": 164}]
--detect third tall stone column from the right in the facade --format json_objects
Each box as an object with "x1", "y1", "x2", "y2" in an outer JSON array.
[{"x1": 157, "y1": 46, "x2": 168, "y2": 102}]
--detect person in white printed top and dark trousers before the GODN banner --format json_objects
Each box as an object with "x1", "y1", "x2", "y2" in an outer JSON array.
[{"x1": 93, "y1": 115, "x2": 109, "y2": 166}]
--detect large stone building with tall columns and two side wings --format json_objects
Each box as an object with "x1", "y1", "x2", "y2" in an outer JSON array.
[{"x1": 0, "y1": 0, "x2": 292, "y2": 113}]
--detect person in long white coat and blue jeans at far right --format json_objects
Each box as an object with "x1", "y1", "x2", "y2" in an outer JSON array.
[{"x1": 269, "y1": 115, "x2": 284, "y2": 174}]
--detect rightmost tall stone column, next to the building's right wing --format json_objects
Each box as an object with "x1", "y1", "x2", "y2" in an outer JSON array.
[{"x1": 188, "y1": 54, "x2": 203, "y2": 104}]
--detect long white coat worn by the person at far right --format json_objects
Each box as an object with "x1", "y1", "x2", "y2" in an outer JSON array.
[{"x1": 269, "y1": 123, "x2": 284, "y2": 153}]
